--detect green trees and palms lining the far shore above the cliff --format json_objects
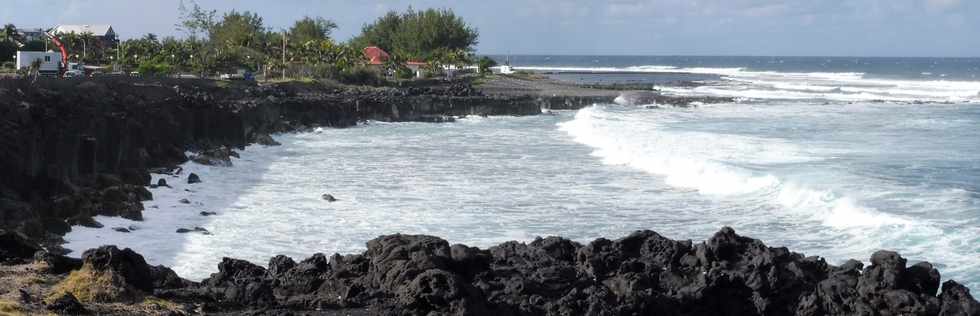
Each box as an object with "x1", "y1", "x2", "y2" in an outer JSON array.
[{"x1": 0, "y1": 0, "x2": 478, "y2": 84}]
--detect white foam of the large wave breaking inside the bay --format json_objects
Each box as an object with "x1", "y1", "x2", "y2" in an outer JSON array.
[{"x1": 560, "y1": 106, "x2": 909, "y2": 228}]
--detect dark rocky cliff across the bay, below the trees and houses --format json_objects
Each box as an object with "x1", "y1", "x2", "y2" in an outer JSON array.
[{"x1": 0, "y1": 78, "x2": 540, "y2": 246}]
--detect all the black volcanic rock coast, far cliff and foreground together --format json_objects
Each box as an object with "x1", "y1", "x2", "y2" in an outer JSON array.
[{"x1": 0, "y1": 78, "x2": 980, "y2": 315}]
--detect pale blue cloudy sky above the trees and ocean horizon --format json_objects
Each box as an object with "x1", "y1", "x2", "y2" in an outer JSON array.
[{"x1": 0, "y1": 0, "x2": 980, "y2": 57}]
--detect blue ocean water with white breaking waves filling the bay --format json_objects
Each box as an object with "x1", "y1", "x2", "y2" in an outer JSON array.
[{"x1": 66, "y1": 56, "x2": 980, "y2": 291}]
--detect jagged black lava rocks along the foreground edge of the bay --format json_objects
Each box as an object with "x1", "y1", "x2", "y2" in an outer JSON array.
[{"x1": 0, "y1": 227, "x2": 980, "y2": 316}]
